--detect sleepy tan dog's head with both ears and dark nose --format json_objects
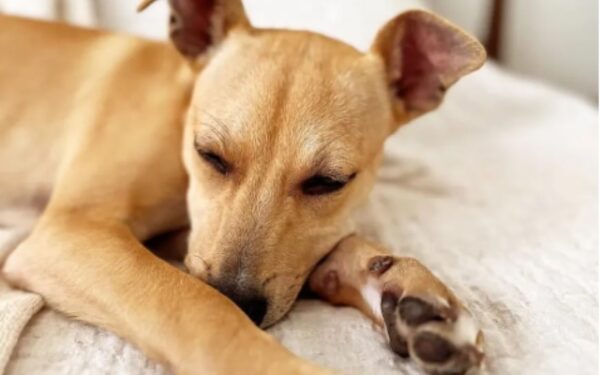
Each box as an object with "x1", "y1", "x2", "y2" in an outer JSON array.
[{"x1": 139, "y1": 0, "x2": 485, "y2": 326}]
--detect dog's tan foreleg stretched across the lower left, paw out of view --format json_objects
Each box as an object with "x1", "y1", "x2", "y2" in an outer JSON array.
[{"x1": 4, "y1": 214, "x2": 330, "y2": 374}]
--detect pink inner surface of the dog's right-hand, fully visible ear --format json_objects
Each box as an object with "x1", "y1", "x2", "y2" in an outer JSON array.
[{"x1": 395, "y1": 19, "x2": 472, "y2": 111}]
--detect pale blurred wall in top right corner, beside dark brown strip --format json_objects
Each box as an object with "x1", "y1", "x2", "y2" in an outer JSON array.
[{"x1": 501, "y1": 0, "x2": 598, "y2": 100}]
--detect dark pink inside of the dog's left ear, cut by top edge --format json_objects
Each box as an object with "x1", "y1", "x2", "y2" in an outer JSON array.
[{"x1": 169, "y1": 0, "x2": 216, "y2": 57}]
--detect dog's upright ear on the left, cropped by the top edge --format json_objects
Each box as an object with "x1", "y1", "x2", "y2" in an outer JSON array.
[{"x1": 138, "y1": 0, "x2": 250, "y2": 61}]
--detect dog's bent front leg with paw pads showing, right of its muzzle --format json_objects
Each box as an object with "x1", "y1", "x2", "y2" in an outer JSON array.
[{"x1": 309, "y1": 236, "x2": 483, "y2": 374}]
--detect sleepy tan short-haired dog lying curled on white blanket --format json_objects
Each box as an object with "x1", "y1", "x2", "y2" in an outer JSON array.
[{"x1": 0, "y1": 0, "x2": 485, "y2": 374}]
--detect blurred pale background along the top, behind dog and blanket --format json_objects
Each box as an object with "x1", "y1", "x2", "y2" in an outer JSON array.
[{"x1": 0, "y1": 0, "x2": 598, "y2": 103}]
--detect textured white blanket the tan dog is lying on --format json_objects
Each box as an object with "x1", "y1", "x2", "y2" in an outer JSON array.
[{"x1": 0, "y1": 65, "x2": 598, "y2": 375}]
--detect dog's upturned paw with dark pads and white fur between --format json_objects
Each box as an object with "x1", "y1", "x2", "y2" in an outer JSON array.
[{"x1": 376, "y1": 260, "x2": 484, "y2": 375}]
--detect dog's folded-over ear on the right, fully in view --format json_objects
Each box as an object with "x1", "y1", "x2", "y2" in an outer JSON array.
[{"x1": 371, "y1": 10, "x2": 486, "y2": 129}]
